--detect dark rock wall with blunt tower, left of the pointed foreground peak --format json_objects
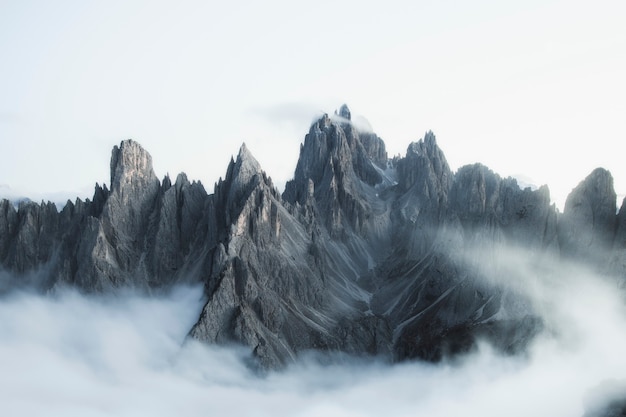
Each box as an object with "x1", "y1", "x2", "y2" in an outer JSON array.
[{"x1": 0, "y1": 140, "x2": 208, "y2": 292}]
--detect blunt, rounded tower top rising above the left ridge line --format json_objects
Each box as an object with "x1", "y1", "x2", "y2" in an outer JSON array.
[{"x1": 111, "y1": 139, "x2": 158, "y2": 192}]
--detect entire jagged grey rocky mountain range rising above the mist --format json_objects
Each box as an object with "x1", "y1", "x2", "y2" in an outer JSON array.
[{"x1": 0, "y1": 106, "x2": 626, "y2": 368}]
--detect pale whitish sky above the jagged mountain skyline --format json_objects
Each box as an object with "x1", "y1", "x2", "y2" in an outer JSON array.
[{"x1": 0, "y1": 0, "x2": 626, "y2": 206}]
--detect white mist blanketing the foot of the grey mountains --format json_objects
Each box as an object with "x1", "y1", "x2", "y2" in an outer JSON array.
[{"x1": 0, "y1": 248, "x2": 626, "y2": 417}]
